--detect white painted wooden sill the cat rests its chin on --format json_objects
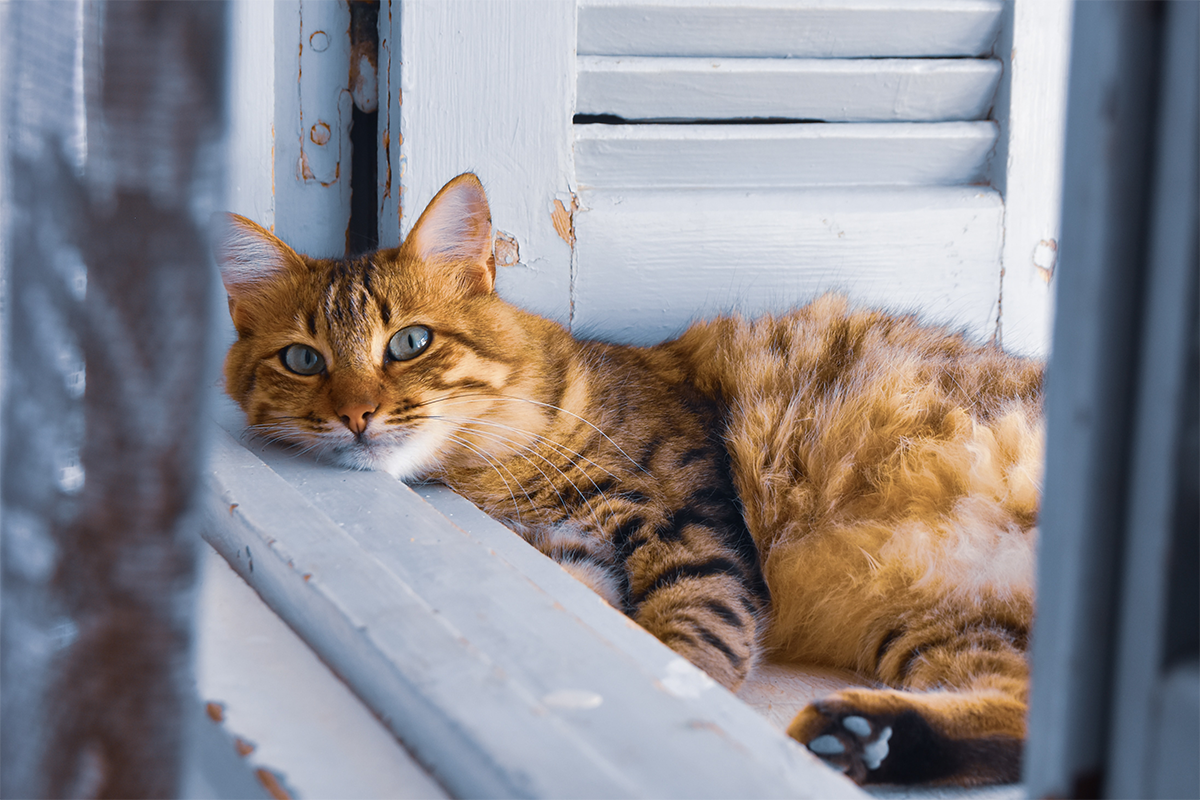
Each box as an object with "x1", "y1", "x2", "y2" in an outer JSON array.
[{"x1": 205, "y1": 404, "x2": 865, "y2": 798}]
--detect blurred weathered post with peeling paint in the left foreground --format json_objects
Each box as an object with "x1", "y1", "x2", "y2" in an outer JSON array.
[{"x1": 0, "y1": 0, "x2": 226, "y2": 798}]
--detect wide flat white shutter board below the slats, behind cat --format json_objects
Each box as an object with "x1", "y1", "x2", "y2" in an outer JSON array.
[{"x1": 574, "y1": 187, "x2": 1003, "y2": 344}]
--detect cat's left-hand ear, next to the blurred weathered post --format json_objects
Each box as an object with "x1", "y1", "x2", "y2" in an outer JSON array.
[{"x1": 212, "y1": 213, "x2": 304, "y2": 332}]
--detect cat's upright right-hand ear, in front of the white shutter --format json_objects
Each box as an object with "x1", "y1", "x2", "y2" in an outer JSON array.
[{"x1": 404, "y1": 173, "x2": 496, "y2": 294}]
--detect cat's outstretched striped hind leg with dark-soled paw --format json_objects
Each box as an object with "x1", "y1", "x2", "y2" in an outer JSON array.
[{"x1": 788, "y1": 621, "x2": 1028, "y2": 786}]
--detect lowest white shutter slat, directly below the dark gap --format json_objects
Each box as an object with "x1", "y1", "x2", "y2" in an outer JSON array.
[{"x1": 575, "y1": 122, "x2": 996, "y2": 188}]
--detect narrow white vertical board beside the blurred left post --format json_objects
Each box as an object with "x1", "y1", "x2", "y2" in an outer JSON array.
[{"x1": 226, "y1": 0, "x2": 275, "y2": 230}]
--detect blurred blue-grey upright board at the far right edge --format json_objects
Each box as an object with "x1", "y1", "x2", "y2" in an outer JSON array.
[{"x1": 1105, "y1": 2, "x2": 1200, "y2": 798}]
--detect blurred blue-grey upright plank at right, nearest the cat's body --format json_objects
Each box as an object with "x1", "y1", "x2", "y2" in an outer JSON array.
[{"x1": 1025, "y1": 2, "x2": 1176, "y2": 798}]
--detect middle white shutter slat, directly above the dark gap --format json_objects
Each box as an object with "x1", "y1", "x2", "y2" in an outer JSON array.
[{"x1": 576, "y1": 55, "x2": 1001, "y2": 122}]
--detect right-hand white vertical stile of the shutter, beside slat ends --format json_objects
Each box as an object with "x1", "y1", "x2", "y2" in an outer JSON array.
[{"x1": 992, "y1": 0, "x2": 1073, "y2": 357}]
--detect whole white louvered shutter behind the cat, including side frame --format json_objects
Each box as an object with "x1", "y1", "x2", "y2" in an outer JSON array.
[{"x1": 380, "y1": 0, "x2": 1070, "y2": 351}]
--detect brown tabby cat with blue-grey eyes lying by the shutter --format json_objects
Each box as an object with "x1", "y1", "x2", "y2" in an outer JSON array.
[{"x1": 217, "y1": 173, "x2": 1043, "y2": 784}]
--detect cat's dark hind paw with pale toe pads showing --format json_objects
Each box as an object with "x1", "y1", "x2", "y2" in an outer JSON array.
[{"x1": 787, "y1": 700, "x2": 893, "y2": 783}]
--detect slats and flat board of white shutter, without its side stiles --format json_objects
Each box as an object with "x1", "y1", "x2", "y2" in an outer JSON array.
[{"x1": 572, "y1": 0, "x2": 1004, "y2": 342}]
